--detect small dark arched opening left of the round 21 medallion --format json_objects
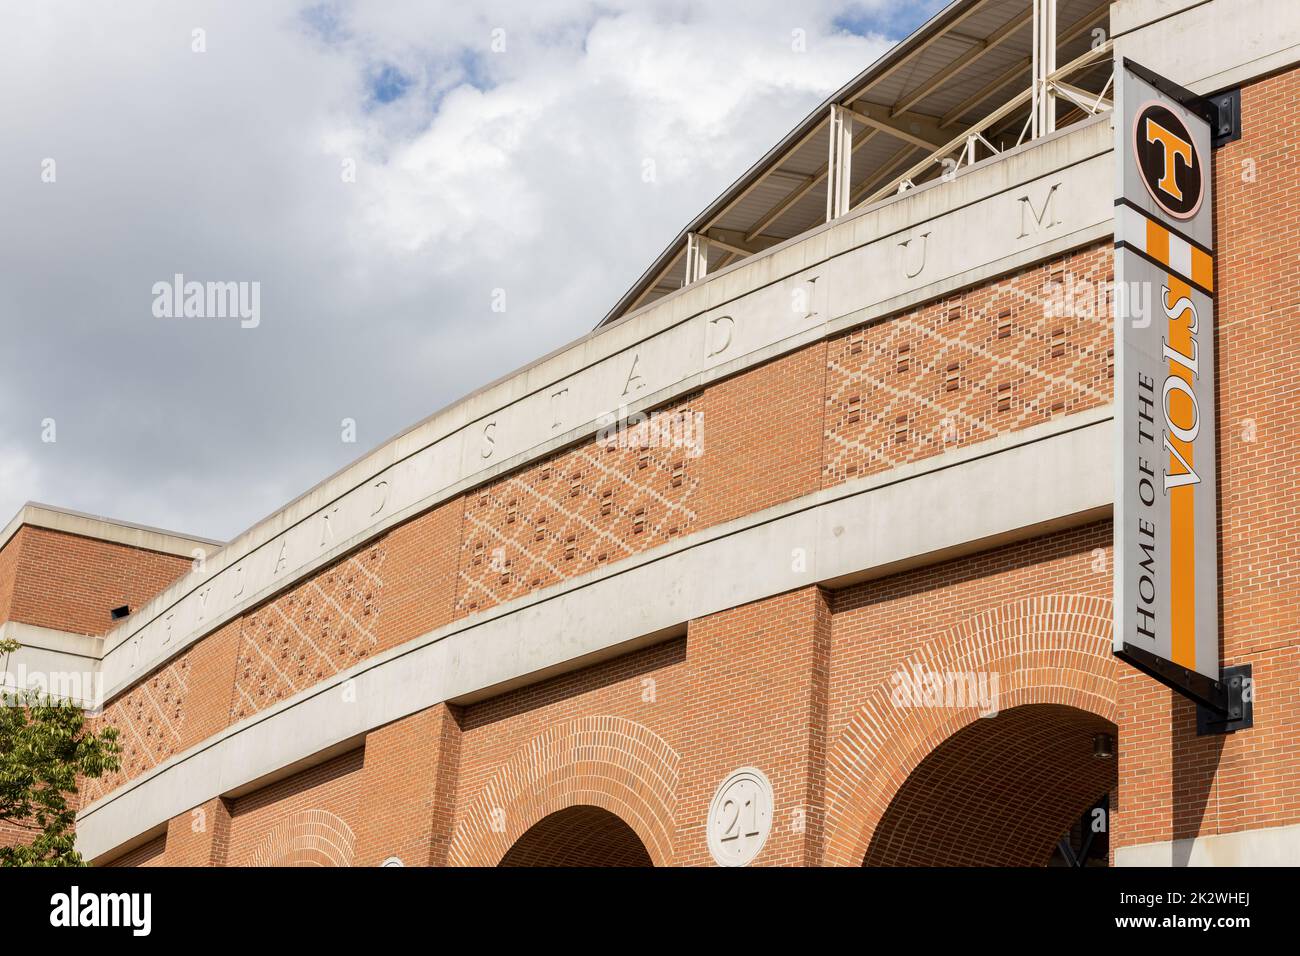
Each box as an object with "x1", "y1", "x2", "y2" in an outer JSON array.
[{"x1": 498, "y1": 806, "x2": 654, "y2": 866}]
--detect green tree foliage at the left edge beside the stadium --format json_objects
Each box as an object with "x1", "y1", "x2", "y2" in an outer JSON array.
[{"x1": 0, "y1": 641, "x2": 121, "y2": 866}]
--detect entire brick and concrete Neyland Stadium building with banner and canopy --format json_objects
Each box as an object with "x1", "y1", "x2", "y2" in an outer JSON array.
[{"x1": 0, "y1": 0, "x2": 1300, "y2": 866}]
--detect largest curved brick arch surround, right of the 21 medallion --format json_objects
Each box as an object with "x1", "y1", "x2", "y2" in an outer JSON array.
[{"x1": 826, "y1": 594, "x2": 1118, "y2": 866}]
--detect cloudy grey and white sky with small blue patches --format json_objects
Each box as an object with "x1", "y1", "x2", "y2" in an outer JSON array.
[{"x1": 0, "y1": 0, "x2": 943, "y2": 540}]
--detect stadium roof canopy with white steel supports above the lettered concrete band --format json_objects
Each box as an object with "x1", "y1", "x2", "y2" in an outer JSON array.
[{"x1": 599, "y1": 0, "x2": 1112, "y2": 325}]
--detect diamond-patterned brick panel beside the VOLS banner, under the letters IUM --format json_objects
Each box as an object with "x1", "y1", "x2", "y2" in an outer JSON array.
[{"x1": 823, "y1": 245, "x2": 1113, "y2": 485}]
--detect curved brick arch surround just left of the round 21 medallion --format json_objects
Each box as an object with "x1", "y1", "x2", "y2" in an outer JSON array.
[{"x1": 447, "y1": 715, "x2": 679, "y2": 866}]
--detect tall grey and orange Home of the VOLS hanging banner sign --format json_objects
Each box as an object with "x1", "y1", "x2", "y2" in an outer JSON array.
[{"x1": 1114, "y1": 61, "x2": 1219, "y2": 688}]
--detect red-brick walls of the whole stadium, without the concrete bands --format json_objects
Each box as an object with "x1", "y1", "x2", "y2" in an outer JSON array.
[{"x1": 0, "y1": 65, "x2": 1300, "y2": 865}]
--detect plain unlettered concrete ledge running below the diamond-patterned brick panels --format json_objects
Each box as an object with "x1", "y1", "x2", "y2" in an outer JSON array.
[{"x1": 78, "y1": 408, "x2": 1113, "y2": 858}]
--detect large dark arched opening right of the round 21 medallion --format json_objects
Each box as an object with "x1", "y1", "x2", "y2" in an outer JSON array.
[{"x1": 862, "y1": 704, "x2": 1118, "y2": 866}]
